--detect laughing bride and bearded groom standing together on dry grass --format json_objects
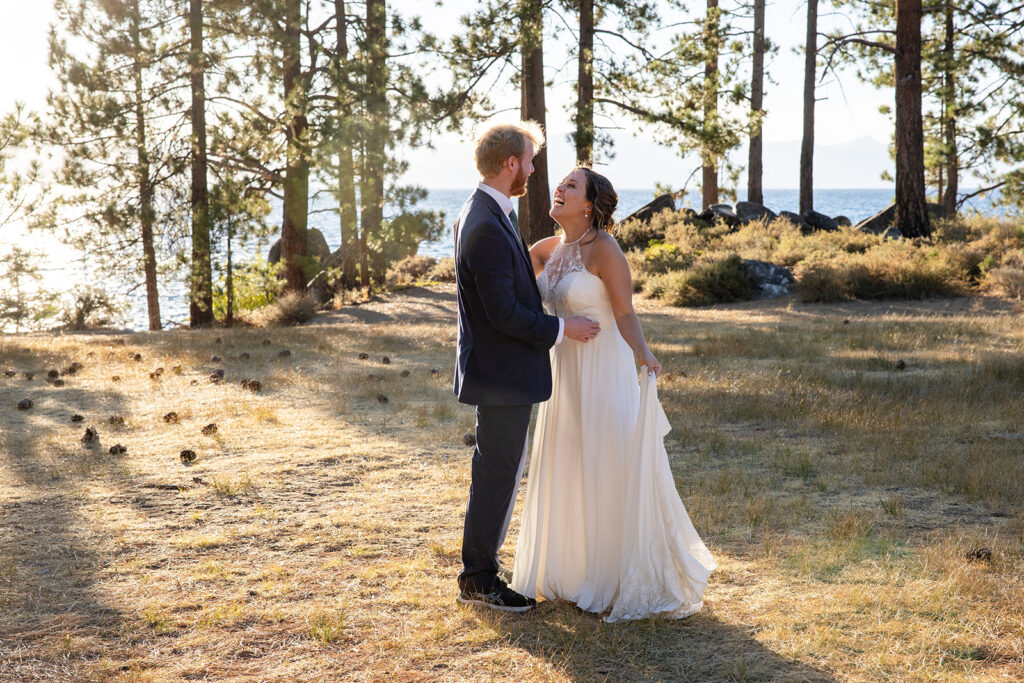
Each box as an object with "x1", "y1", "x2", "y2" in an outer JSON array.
[{"x1": 455, "y1": 122, "x2": 716, "y2": 622}]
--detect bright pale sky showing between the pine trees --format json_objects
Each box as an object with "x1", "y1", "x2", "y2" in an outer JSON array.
[{"x1": 0, "y1": 0, "x2": 892, "y2": 189}]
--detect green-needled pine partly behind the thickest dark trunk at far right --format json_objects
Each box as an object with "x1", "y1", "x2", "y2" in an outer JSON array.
[{"x1": 823, "y1": 0, "x2": 1024, "y2": 212}]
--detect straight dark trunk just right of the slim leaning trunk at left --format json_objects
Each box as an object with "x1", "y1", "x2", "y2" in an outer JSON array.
[{"x1": 188, "y1": 0, "x2": 213, "y2": 328}]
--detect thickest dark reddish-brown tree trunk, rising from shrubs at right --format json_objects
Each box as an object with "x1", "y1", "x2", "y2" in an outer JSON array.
[{"x1": 895, "y1": 0, "x2": 931, "y2": 238}]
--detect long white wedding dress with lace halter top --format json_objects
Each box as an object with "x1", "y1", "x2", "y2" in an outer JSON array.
[{"x1": 510, "y1": 240, "x2": 716, "y2": 622}]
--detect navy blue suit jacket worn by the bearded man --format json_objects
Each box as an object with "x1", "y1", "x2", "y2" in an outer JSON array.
[{"x1": 455, "y1": 189, "x2": 558, "y2": 405}]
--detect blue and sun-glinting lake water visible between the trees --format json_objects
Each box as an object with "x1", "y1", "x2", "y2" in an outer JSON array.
[{"x1": 0, "y1": 189, "x2": 997, "y2": 330}]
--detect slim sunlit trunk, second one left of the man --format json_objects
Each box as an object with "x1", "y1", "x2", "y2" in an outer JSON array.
[{"x1": 334, "y1": 0, "x2": 359, "y2": 289}]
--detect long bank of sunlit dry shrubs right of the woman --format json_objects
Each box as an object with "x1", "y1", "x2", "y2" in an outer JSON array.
[{"x1": 620, "y1": 212, "x2": 1024, "y2": 305}]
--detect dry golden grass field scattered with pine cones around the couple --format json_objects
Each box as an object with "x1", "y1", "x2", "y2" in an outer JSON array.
[{"x1": 0, "y1": 287, "x2": 1024, "y2": 681}]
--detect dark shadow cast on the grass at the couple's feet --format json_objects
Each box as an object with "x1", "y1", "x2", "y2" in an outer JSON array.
[{"x1": 480, "y1": 601, "x2": 837, "y2": 681}]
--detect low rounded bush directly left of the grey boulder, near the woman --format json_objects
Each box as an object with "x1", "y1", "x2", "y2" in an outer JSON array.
[{"x1": 644, "y1": 254, "x2": 755, "y2": 306}]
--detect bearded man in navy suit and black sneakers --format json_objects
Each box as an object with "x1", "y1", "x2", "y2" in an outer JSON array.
[{"x1": 455, "y1": 122, "x2": 600, "y2": 612}]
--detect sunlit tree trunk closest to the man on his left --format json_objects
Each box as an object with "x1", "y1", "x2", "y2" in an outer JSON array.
[{"x1": 359, "y1": 0, "x2": 388, "y2": 286}]
